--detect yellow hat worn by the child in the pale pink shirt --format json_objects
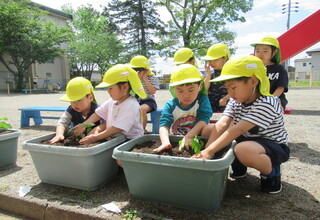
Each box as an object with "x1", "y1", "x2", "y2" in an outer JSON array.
[{"x1": 96, "y1": 64, "x2": 147, "y2": 99}]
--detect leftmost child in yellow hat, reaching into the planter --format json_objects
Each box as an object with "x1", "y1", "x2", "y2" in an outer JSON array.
[{"x1": 50, "y1": 77, "x2": 100, "y2": 143}]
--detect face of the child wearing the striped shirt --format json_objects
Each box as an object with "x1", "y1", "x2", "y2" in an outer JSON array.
[{"x1": 224, "y1": 77, "x2": 258, "y2": 104}]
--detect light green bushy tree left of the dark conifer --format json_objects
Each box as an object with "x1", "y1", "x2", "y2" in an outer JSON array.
[{"x1": 63, "y1": 5, "x2": 124, "y2": 80}]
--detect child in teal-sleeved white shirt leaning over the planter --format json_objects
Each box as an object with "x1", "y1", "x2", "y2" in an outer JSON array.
[{"x1": 155, "y1": 64, "x2": 212, "y2": 152}]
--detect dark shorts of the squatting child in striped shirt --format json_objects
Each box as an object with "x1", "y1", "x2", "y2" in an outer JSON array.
[{"x1": 236, "y1": 136, "x2": 290, "y2": 166}]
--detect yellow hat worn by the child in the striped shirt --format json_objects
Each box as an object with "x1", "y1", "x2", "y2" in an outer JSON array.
[{"x1": 210, "y1": 55, "x2": 272, "y2": 96}]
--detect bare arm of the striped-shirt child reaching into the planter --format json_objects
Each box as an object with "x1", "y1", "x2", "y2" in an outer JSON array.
[{"x1": 193, "y1": 120, "x2": 256, "y2": 159}]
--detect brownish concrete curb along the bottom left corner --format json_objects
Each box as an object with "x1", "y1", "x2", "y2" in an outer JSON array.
[{"x1": 0, "y1": 194, "x2": 111, "y2": 220}]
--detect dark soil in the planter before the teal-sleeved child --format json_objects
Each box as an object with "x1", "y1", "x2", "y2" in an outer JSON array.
[{"x1": 131, "y1": 140, "x2": 229, "y2": 159}]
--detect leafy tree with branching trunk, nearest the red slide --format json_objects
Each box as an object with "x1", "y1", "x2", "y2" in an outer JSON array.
[{"x1": 157, "y1": 0, "x2": 253, "y2": 55}]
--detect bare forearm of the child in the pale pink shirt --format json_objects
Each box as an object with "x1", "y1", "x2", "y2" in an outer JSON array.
[{"x1": 79, "y1": 125, "x2": 122, "y2": 144}]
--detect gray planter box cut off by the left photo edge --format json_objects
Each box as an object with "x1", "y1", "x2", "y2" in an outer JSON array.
[{"x1": 0, "y1": 129, "x2": 21, "y2": 169}]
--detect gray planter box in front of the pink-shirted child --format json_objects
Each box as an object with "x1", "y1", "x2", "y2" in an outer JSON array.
[{"x1": 22, "y1": 134, "x2": 126, "y2": 191}]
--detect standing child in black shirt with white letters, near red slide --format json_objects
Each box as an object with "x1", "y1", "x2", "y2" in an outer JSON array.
[{"x1": 251, "y1": 35, "x2": 289, "y2": 110}]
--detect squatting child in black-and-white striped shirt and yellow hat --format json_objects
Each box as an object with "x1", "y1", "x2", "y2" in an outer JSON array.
[{"x1": 194, "y1": 56, "x2": 290, "y2": 193}]
